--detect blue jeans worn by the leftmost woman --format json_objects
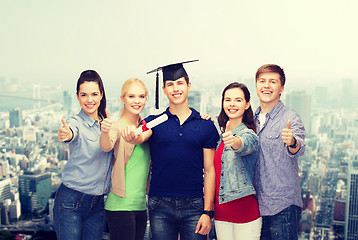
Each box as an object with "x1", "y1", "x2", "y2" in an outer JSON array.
[{"x1": 53, "y1": 184, "x2": 104, "y2": 240}]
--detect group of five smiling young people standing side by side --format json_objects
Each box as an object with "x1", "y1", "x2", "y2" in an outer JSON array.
[{"x1": 53, "y1": 63, "x2": 305, "y2": 240}]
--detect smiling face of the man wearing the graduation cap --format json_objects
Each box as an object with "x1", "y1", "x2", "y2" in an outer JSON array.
[{"x1": 163, "y1": 77, "x2": 191, "y2": 105}]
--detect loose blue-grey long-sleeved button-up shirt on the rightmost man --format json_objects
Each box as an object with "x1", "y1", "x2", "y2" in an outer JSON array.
[{"x1": 255, "y1": 101, "x2": 305, "y2": 216}]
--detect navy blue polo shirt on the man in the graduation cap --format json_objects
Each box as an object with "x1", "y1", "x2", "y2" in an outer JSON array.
[{"x1": 145, "y1": 108, "x2": 219, "y2": 198}]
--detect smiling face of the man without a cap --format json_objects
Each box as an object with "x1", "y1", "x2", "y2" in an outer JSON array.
[{"x1": 256, "y1": 72, "x2": 284, "y2": 109}]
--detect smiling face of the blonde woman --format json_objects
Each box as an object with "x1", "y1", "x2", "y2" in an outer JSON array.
[{"x1": 121, "y1": 83, "x2": 147, "y2": 115}]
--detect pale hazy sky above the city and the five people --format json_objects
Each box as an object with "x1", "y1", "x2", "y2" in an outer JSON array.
[{"x1": 0, "y1": 0, "x2": 358, "y2": 95}]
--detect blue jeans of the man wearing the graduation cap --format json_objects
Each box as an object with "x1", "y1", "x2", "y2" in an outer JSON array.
[{"x1": 148, "y1": 197, "x2": 207, "y2": 240}]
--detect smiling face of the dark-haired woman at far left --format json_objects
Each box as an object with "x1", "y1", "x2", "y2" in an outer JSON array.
[{"x1": 77, "y1": 82, "x2": 102, "y2": 120}]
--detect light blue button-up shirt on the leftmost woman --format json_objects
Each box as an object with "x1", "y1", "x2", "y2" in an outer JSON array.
[{"x1": 62, "y1": 110, "x2": 113, "y2": 195}]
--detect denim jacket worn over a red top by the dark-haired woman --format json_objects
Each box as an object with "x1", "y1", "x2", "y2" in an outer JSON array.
[{"x1": 218, "y1": 123, "x2": 258, "y2": 204}]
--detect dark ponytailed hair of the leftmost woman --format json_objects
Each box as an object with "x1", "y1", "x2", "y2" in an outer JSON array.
[{"x1": 76, "y1": 70, "x2": 107, "y2": 118}]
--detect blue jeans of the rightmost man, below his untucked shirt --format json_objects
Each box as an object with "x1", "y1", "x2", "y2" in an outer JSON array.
[{"x1": 260, "y1": 205, "x2": 302, "y2": 240}]
